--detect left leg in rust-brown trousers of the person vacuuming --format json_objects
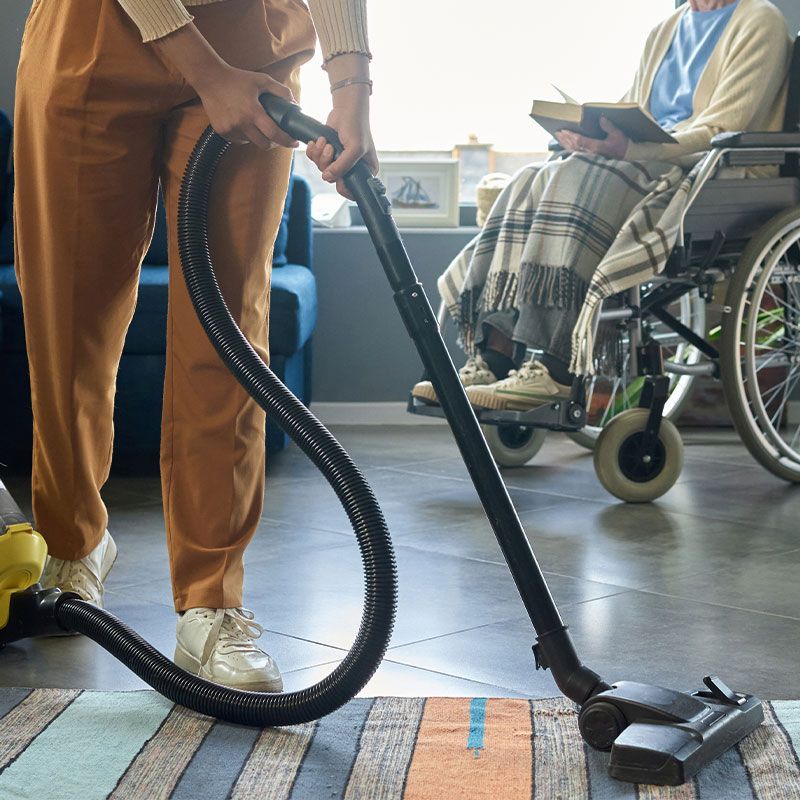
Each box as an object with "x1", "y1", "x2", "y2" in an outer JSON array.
[{"x1": 14, "y1": 0, "x2": 175, "y2": 560}]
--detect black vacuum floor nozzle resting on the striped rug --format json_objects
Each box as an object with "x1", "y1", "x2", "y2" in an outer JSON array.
[{"x1": 578, "y1": 676, "x2": 764, "y2": 786}]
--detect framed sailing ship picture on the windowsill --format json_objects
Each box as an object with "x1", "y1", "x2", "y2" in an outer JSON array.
[{"x1": 378, "y1": 158, "x2": 459, "y2": 228}]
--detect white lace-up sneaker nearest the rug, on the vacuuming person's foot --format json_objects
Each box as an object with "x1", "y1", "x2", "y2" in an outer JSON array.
[{"x1": 175, "y1": 608, "x2": 283, "y2": 692}]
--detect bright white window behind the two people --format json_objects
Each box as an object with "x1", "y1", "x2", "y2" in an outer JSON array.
[{"x1": 302, "y1": 0, "x2": 675, "y2": 196}]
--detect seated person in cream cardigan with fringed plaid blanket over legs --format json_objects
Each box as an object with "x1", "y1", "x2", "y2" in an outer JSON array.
[{"x1": 412, "y1": 0, "x2": 791, "y2": 410}]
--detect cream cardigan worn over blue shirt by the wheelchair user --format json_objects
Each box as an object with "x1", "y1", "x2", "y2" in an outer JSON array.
[{"x1": 624, "y1": 0, "x2": 792, "y2": 166}]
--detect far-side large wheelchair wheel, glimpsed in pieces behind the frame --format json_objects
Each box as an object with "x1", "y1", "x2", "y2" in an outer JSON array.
[{"x1": 567, "y1": 290, "x2": 706, "y2": 450}]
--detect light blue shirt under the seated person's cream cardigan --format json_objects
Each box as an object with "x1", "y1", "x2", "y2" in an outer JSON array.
[{"x1": 650, "y1": 0, "x2": 739, "y2": 131}]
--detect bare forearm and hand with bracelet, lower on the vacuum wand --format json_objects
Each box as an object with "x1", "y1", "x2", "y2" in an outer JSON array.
[{"x1": 306, "y1": 54, "x2": 378, "y2": 200}]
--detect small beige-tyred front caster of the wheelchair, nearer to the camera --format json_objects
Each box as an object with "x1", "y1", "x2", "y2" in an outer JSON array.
[{"x1": 594, "y1": 408, "x2": 683, "y2": 503}]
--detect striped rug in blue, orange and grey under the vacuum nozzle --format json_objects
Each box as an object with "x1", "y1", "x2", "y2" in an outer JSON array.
[{"x1": 0, "y1": 689, "x2": 800, "y2": 800}]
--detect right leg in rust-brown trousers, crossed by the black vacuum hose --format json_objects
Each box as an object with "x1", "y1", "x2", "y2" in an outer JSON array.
[{"x1": 161, "y1": 0, "x2": 314, "y2": 611}]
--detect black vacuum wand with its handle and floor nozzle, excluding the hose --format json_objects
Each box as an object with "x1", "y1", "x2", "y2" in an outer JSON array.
[{"x1": 261, "y1": 90, "x2": 764, "y2": 784}]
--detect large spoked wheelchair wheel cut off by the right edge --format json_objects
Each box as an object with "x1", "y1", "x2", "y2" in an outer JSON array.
[{"x1": 720, "y1": 208, "x2": 800, "y2": 483}]
